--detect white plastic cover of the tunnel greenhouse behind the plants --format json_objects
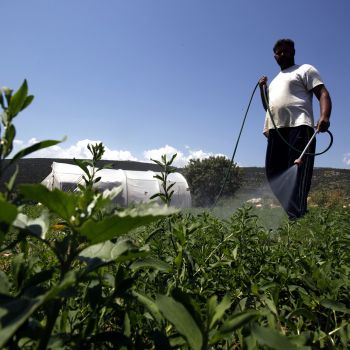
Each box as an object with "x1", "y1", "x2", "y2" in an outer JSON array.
[{"x1": 42, "y1": 162, "x2": 191, "y2": 208}]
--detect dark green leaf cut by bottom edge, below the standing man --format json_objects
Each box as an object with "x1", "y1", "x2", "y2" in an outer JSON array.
[{"x1": 251, "y1": 325, "x2": 299, "y2": 350}]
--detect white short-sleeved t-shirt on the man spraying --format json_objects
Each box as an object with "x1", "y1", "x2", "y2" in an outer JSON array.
[{"x1": 264, "y1": 64, "x2": 323, "y2": 133}]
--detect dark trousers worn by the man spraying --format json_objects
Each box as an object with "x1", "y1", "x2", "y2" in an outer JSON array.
[{"x1": 265, "y1": 125, "x2": 316, "y2": 219}]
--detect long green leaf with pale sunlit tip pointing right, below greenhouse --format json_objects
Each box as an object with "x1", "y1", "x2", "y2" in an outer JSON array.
[{"x1": 79, "y1": 205, "x2": 177, "y2": 243}]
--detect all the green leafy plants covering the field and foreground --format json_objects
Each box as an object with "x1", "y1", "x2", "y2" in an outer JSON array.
[{"x1": 0, "y1": 80, "x2": 350, "y2": 350}]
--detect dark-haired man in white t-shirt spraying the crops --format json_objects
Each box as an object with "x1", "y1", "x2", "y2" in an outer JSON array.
[{"x1": 259, "y1": 39, "x2": 332, "y2": 219}]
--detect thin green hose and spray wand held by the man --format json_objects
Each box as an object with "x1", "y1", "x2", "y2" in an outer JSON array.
[{"x1": 213, "y1": 83, "x2": 333, "y2": 207}]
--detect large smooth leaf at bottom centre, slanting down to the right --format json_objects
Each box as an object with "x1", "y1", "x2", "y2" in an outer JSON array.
[{"x1": 156, "y1": 295, "x2": 203, "y2": 350}]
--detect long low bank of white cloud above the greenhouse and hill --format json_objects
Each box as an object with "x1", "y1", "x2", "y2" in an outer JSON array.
[{"x1": 13, "y1": 137, "x2": 223, "y2": 167}]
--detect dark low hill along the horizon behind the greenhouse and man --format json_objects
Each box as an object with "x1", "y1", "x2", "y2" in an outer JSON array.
[{"x1": 0, "y1": 158, "x2": 350, "y2": 196}]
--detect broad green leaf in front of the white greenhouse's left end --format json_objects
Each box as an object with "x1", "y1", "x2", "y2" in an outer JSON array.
[{"x1": 19, "y1": 184, "x2": 78, "y2": 222}]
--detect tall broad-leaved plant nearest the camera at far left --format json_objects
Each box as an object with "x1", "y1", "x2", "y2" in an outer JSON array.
[{"x1": 0, "y1": 82, "x2": 173, "y2": 349}]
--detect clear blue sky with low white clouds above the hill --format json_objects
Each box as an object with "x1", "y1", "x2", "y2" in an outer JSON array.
[{"x1": 0, "y1": 0, "x2": 350, "y2": 168}]
